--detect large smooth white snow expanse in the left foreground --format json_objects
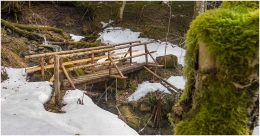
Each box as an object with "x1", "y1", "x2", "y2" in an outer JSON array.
[{"x1": 1, "y1": 68, "x2": 138, "y2": 135}]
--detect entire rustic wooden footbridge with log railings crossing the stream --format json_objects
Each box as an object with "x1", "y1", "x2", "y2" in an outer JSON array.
[{"x1": 25, "y1": 41, "x2": 178, "y2": 104}]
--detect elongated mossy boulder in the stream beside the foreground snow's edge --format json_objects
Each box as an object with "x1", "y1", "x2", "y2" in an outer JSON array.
[{"x1": 119, "y1": 106, "x2": 139, "y2": 129}]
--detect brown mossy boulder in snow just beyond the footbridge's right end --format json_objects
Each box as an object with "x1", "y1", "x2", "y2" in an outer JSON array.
[{"x1": 156, "y1": 54, "x2": 178, "y2": 68}]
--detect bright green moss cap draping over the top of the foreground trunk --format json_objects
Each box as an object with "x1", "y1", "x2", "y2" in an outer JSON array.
[{"x1": 181, "y1": 1, "x2": 259, "y2": 101}]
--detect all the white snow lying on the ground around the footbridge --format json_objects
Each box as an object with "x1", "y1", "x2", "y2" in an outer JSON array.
[{"x1": 1, "y1": 22, "x2": 259, "y2": 135}]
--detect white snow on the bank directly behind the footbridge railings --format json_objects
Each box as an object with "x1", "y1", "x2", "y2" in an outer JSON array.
[{"x1": 98, "y1": 27, "x2": 186, "y2": 65}]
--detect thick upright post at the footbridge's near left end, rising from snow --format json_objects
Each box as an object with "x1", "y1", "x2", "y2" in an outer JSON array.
[{"x1": 54, "y1": 55, "x2": 60, "y2": 105}]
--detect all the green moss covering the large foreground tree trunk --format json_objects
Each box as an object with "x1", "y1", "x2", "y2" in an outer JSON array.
[{"x1": 174, "y1": 2, "x2": 259, "y2": 135}]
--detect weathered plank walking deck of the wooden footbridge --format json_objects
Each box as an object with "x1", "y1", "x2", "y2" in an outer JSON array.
[{"x1": 63, "y1": 63, "x2": 145, "y2": 86}]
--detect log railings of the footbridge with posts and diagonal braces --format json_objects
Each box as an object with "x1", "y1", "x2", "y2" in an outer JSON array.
[{"x1": 25, "y1": 41, "x2": 163, "y2": 95}]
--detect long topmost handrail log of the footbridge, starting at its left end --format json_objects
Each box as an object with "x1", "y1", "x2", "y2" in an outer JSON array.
[{"x1": 24, "y1": 41, "x2": 141, "y2": 59}]
